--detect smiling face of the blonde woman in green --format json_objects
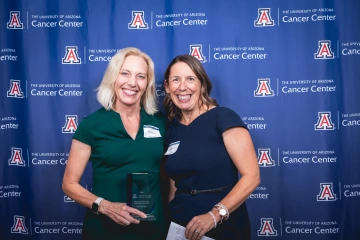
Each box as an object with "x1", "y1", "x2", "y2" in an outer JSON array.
[{"x1": 115, "y1": 55, "x2": 148, "y2": 108}]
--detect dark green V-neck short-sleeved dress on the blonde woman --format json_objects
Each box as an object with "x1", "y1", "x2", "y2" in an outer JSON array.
[{"x1": 73, "y1": 108, "x2": 166, "y2": 240}]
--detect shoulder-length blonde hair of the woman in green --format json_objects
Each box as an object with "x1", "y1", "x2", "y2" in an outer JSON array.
[{"x1": 96, "y1": 47, "x2": 158, "y2": 115}]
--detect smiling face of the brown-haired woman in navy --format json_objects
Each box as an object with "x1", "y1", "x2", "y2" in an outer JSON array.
[{"x1": 165, "y1": 62, "x2": 201, "y2": 113}]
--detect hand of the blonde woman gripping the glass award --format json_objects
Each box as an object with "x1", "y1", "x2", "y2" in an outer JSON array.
[{"x1": 99, "y1": 200, "x2": 146, "y2": 226}]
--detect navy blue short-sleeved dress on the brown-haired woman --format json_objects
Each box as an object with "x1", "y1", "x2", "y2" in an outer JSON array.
[{"x1": 165, "y1": 107, "x2": 251, "y2": 240}]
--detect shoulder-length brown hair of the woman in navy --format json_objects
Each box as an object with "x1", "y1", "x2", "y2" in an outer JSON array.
[{"x1": 164, "y1": 54, "x2": 218, "y2": 121}]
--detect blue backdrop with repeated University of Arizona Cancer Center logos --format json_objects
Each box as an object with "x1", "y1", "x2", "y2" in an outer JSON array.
[{"x1": 0, "y1": 0, "x2": 360, "y2": 240}]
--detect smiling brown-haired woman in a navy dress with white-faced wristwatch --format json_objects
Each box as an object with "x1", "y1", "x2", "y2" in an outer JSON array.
[{"x1": 164, "y1": 55, "x2": 260, "y2": 240}]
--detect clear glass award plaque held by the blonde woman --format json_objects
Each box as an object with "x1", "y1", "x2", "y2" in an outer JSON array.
[{"x1": 126, "y1": 173, "x2": 158, "y2": 221}]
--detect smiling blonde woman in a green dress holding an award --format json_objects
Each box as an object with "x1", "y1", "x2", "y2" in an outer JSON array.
[{"x1": 62, "y1": 48, "x2": 165, "y2": 240}]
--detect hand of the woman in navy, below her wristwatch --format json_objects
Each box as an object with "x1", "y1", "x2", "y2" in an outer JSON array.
[{"x1": 185, "y1": 213, "x2": 215, "y2": 240}]
